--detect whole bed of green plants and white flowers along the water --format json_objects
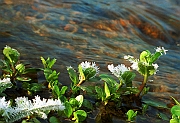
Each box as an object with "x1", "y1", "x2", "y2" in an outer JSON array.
[{"x1": 0, "y1": 46, "x2": 171, "y2": 123}]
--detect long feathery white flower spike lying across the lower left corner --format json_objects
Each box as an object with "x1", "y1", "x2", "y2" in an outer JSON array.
[{"x1": 0, "y1": 96, "x2": 65, "y2": 122}]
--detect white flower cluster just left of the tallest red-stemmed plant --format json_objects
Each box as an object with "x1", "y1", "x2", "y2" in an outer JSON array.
[{"x1": 108, "y1": 64, "x2": 130, "y2": 78}]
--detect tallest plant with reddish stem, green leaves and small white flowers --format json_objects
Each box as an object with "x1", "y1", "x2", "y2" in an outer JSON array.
[{"x1": 124, "y1": 47, "x2": 167, "y2": 97}]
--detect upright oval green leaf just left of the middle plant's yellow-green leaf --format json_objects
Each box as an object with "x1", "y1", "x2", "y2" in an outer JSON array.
[{"x1": 67, "y1": 67, "x2": 79, "y2": 85}]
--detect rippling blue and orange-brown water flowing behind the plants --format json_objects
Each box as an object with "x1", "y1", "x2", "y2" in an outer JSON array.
[{"x1": 0, "y1": 0, "x2": 180, "y2": 122}]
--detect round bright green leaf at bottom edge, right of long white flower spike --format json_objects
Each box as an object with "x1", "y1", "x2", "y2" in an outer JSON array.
[{"x1": 73, "y1": 110, "x2": 87, "y2": 122}]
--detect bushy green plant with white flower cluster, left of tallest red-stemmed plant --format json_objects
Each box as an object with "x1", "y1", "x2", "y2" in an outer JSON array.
[{"x1": 95, "y1": 64, "x2": 138, "y2": 105}]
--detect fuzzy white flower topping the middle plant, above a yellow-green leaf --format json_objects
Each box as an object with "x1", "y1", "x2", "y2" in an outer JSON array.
[{"x1": 80, "y1": 61, "x2": 99, "y2": 74}]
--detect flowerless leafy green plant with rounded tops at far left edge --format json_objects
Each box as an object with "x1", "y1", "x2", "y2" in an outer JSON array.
[{"x1": 0, "y1": 46, "x2": 40, "y2": 85}]
